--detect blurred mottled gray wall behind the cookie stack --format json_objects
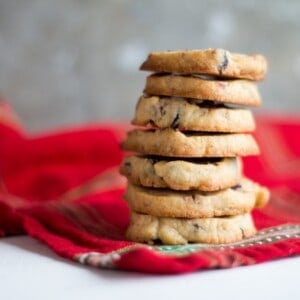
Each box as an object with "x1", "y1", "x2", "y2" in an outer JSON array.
[{"x1": 0, "y1": 0, "x2": 300, "y2": 131}]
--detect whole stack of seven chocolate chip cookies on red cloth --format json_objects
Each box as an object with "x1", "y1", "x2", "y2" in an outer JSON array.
[{"x1": 120, "y1": 49, "x2": 269, "y2": 244}]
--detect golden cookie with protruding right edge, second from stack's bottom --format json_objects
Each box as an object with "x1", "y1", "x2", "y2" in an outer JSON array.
[{"x1": 125, "y1": 179, "x2": 269, "y2": 219}]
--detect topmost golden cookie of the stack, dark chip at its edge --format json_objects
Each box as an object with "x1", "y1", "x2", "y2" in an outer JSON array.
[{"x1": 140, "y1": 49, "x2": 267, "y2": 80}]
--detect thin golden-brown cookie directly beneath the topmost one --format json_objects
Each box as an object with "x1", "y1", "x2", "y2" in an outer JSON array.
[{"x1": 144, "y1": 75, "x2": 261, "y2": 106}]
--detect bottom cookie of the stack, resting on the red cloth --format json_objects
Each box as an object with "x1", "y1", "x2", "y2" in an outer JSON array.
[{"x1": 126, "y1": 212, "x2": 256, "y2": 245}]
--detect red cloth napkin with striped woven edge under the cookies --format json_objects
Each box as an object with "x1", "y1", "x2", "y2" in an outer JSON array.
[{"x1": 0, "y1": 102, "x2": 300, "y2": 274}]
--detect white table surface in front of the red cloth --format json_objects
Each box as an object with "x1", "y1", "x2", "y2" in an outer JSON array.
[{"x1": 0, "y1": 236, "x2": 300, "y2": 300}]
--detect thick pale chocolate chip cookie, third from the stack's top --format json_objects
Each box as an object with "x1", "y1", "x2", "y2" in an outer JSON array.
[{"x1": 132, "y1": 96, "x2": 255, "y2": 132}]
